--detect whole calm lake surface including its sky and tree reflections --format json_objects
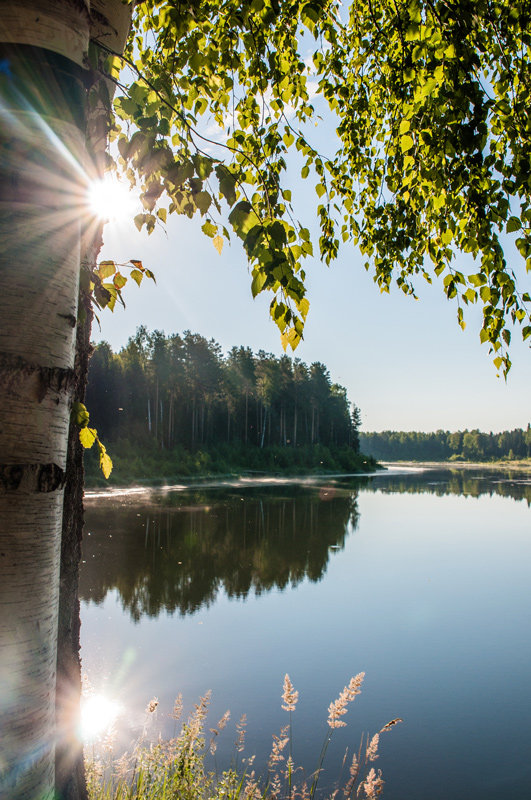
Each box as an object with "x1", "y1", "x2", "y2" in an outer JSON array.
[{"x1": 80, "y1": 469, "x2": 531, "y2": 800}]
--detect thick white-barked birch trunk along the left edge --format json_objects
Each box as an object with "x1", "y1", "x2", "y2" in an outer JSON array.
[{"x1": 0, "y1": 18, "x2": 89, "y2": 800}]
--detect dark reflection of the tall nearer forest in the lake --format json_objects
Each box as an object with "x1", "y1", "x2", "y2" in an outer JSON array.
[{"x1": 80, "y1": 489, "x2": 358, "y2": 620}]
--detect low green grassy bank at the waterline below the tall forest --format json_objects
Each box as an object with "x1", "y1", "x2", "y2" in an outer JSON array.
[{"x1": 85, "y1": 439, "x2": 378, "y2": 487}]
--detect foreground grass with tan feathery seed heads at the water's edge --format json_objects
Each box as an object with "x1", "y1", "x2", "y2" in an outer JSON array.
[{"x1": 86, "y1": 673, "x2": 396, "y2": 800}]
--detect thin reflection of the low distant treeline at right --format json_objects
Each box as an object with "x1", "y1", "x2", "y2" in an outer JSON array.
[{"x1": 370, "y1": 469, "x2": 531, "y2": 505}]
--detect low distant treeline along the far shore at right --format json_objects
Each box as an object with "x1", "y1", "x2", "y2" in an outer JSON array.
[{"x1": 359, "y1": 425, "x2": 531, "y2": 461}]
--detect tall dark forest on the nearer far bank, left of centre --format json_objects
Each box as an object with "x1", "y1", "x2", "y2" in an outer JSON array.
[{"x1": 87, "y1": 326, "x2": 370, "y2": 482}]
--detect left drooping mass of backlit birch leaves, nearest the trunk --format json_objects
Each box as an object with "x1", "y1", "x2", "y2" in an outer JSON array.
[{"x1": 95, "y1": 0, "x2": 337, "y2": 348}]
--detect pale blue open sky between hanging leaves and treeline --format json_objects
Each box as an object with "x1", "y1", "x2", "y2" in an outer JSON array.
[{"x1": 93, "y1": 203, "x2": 531, "y2": 431}]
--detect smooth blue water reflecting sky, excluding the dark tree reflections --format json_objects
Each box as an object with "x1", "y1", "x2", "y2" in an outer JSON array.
[{"x1": 82, "y1": 468, "x2": 531, "y2": 800}]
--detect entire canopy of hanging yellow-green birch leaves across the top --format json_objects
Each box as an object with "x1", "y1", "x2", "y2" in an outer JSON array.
[{"x1": 92, "y1": 0, "x2": 531, "y2": 373}]
